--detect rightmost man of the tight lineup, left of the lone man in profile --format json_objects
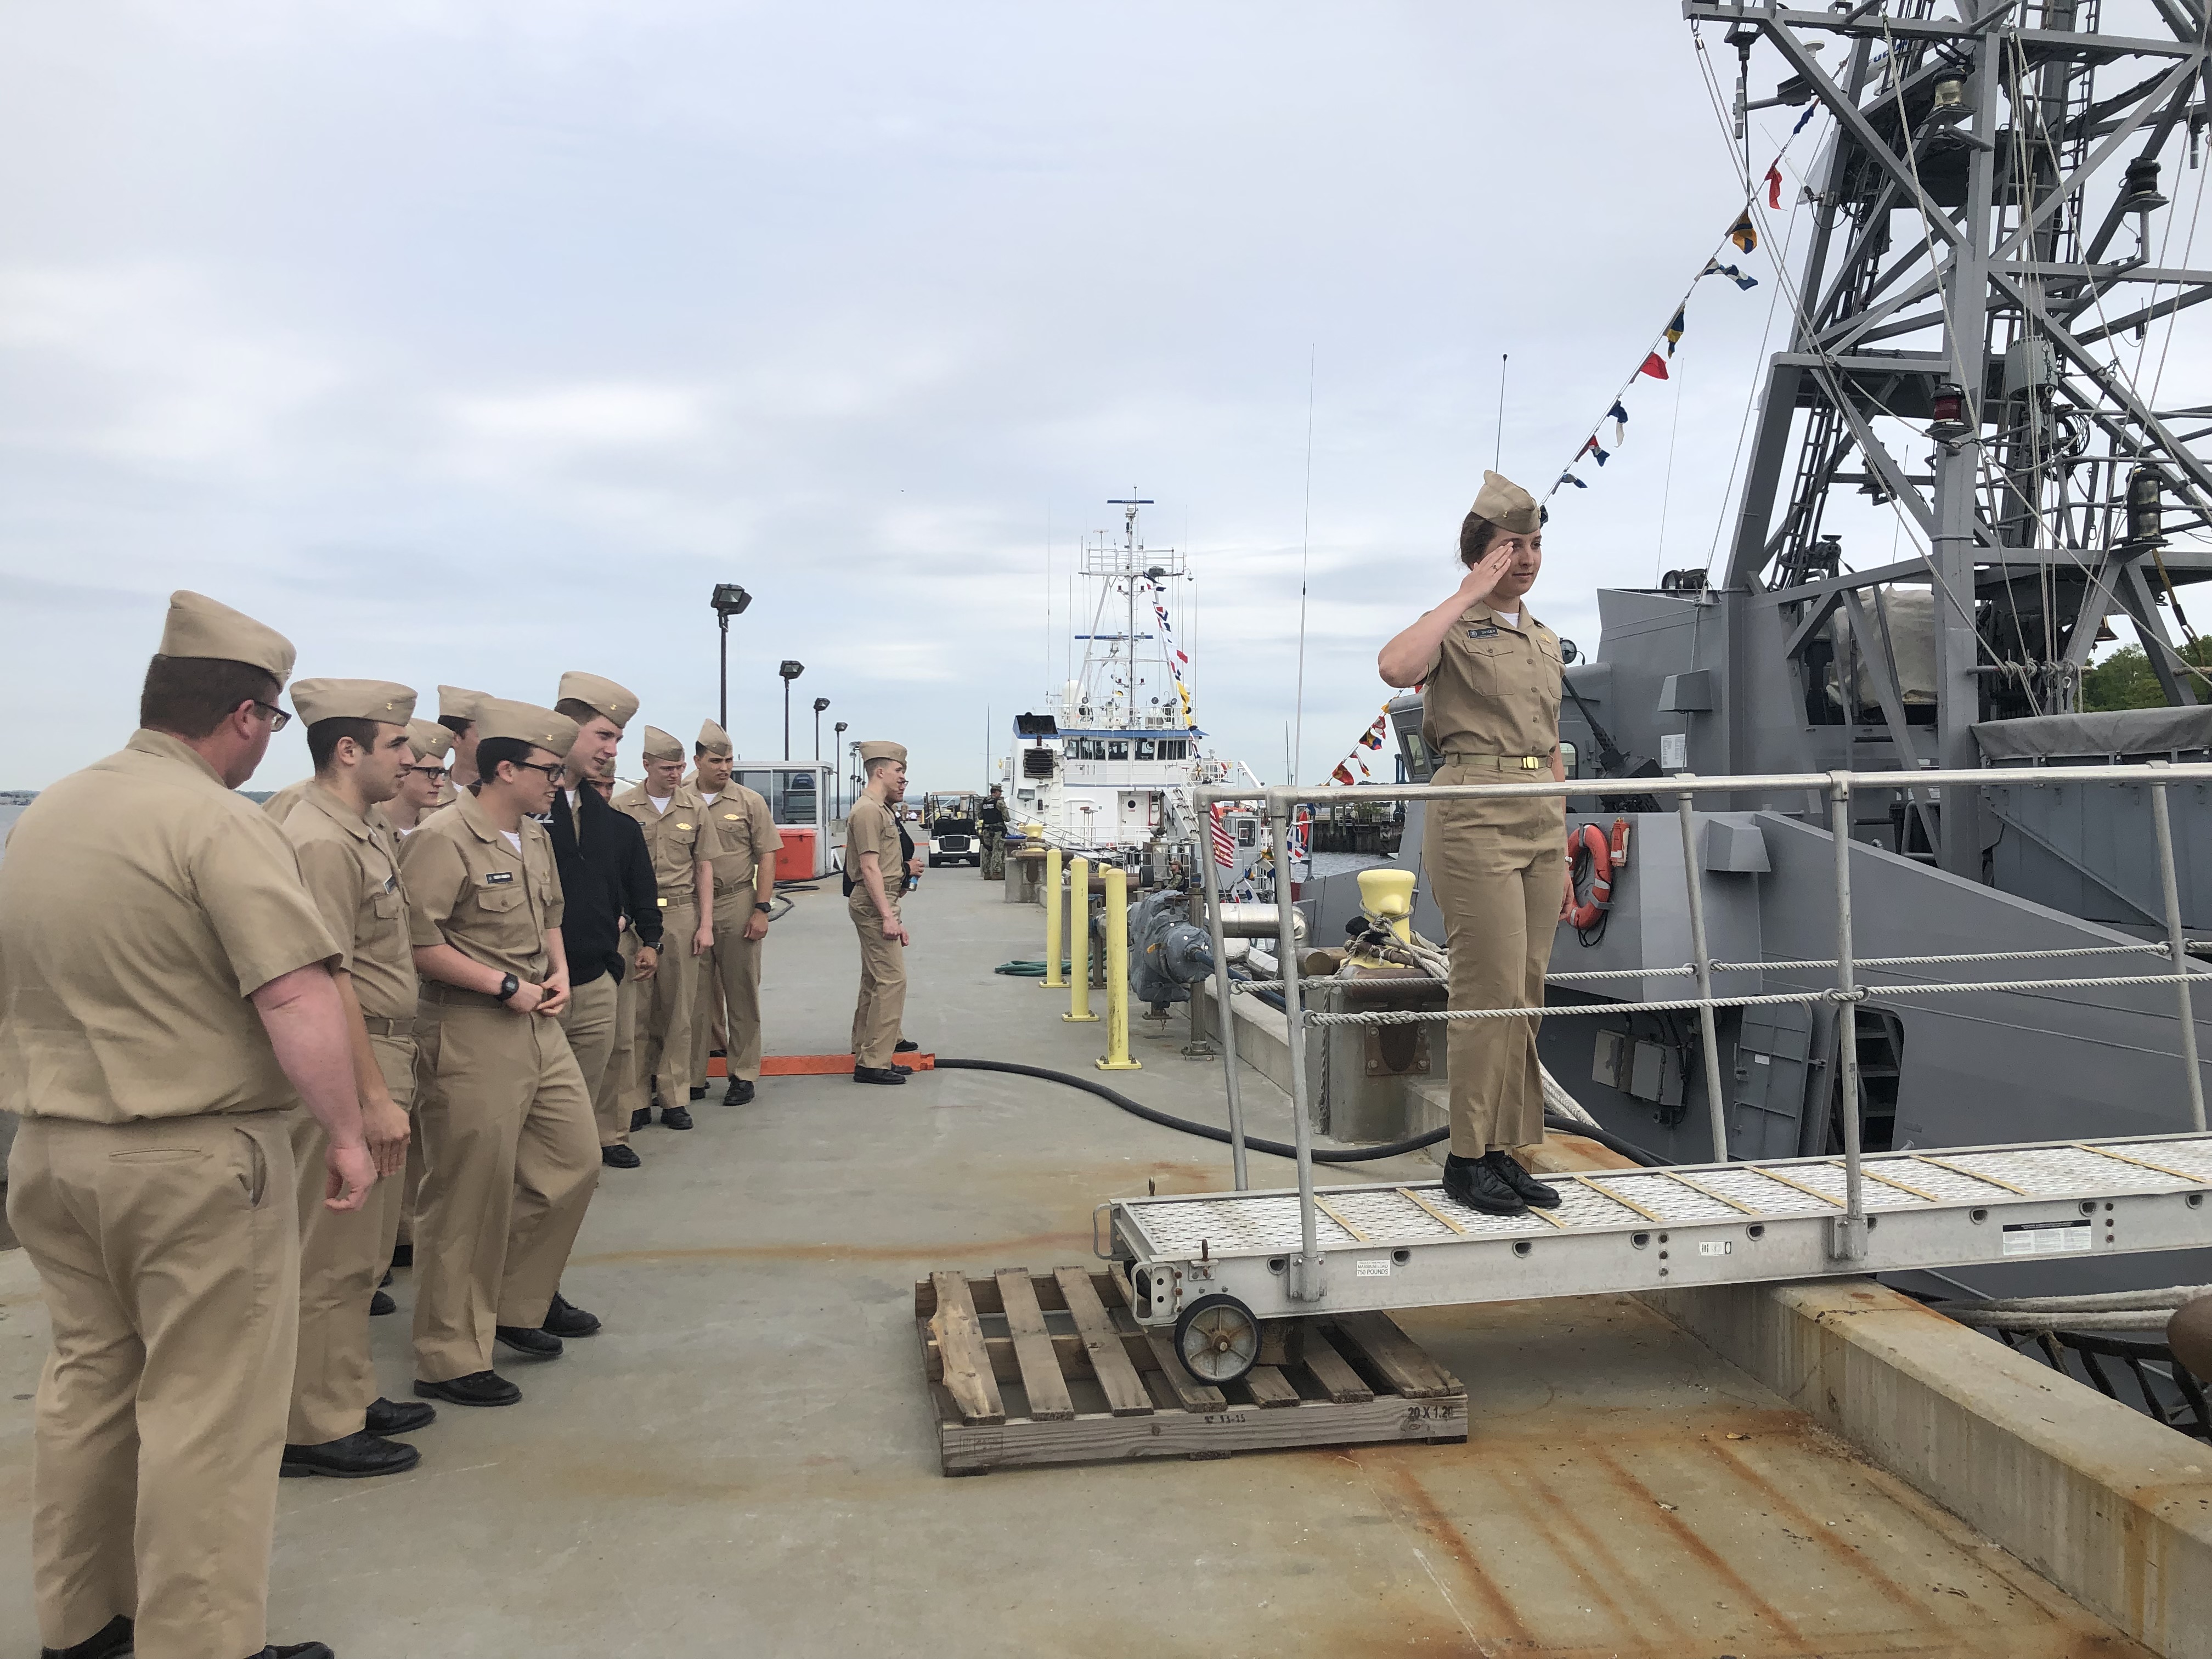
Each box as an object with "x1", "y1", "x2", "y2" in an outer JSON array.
[{"x1": 692, "y1": 721, "x2": 783, "y2": 1106}]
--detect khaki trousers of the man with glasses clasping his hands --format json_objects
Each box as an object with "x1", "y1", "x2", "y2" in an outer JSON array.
[{"x1": 414, "y1": 991, "x2": 600, "y2": 1383}]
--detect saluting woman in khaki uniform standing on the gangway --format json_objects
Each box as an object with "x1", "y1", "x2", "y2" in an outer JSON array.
[{"x1": 1376, "y1": 471, "x2": 1575, "y2": 1215}]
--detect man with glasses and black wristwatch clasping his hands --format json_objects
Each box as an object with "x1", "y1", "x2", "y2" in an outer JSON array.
[{"x1": 400, "y1": 697, "x2": 600, "y2": 1407}]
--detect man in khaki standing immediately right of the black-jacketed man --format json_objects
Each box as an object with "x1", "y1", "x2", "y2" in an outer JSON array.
[{"x1": 615, "y1": 725, "x2": 721, "y2": 1128}]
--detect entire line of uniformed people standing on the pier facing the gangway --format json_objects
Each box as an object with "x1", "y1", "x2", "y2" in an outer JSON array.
[{"x1": 0, "y1": 593, "x2": 907, "y2": 1659}]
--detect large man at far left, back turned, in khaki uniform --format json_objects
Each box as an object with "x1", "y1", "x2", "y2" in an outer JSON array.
[{"x1": 0, "y1": 593, "x2": 376, "y2": 1659}]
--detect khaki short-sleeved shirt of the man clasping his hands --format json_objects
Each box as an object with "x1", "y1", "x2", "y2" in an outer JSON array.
[{"x1": 400, "y1": 794, "x2": 562, "y2": 984}]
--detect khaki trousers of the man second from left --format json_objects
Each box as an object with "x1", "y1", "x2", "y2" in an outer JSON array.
[{"x1": 283, "y1": 1033, "x2": 420, "y2": 1447}]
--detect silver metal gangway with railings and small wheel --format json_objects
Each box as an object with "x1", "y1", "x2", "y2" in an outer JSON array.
[{"x1": 1099, "y1": 763, "x2": 2212, "y2": 1383}]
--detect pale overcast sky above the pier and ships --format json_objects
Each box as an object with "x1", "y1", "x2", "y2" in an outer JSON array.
[{"x1": 0, "y1": 0, "x2": 2203, "y2": 787}]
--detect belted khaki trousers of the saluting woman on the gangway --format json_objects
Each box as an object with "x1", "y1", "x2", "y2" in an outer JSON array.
[{"x1": 1420, "y1": 765, "x2": 1566, "y2": 1157}]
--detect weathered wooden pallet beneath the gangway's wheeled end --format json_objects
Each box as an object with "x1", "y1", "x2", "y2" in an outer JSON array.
[{"x1": 913, "y1": 1267, "x2": 1466, "y2": 1475}]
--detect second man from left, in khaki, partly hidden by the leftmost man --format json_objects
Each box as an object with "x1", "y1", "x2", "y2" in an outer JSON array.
[{"x1": 283, "y1": 679, "x2": 442, "y2": 1477}]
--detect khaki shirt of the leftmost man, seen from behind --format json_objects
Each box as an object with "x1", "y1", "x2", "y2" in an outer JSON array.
[{"x1": 0, "y1": 730, "x2": 338, "y2": 1124}]
